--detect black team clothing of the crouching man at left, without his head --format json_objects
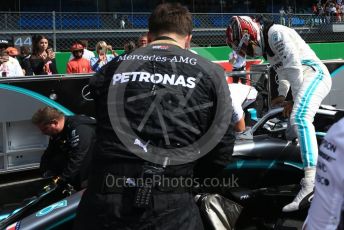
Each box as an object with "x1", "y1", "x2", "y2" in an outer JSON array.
[{"x1": 40, "y1": 115, "x2": 96, "y2": 189}]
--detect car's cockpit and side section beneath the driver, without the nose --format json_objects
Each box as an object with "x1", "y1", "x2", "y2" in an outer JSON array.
[{"x1": 220, "y1": 106, "x2": 343, "y2": 229}]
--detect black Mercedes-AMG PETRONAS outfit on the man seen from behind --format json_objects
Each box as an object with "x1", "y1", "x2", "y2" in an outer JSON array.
[{"x1": 75, "y1": 39, "x2": 233, "y2": 230}]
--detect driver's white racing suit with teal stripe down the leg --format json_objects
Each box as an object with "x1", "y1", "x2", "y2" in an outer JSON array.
[{"x1": 262, "y1": 24, "x2": 332, "y2": 168}]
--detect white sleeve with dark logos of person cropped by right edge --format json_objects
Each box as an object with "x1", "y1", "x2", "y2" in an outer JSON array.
[{"x1": 304, "y1": 119, "x2": 344, "y2": 230}]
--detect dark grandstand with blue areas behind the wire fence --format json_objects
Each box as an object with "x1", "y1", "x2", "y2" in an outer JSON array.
[{"x1": 0, "y1": 0, "x2": 344, "y2": 51}]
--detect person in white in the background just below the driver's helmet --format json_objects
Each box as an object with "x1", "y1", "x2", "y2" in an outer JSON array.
[{"x1": 229, "y1": 50, "x2": 246, "y2": 85}]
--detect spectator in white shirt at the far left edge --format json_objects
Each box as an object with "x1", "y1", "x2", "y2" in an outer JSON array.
[{"x1": 0, "y1": 50, "x2": 24, "y2": 77}]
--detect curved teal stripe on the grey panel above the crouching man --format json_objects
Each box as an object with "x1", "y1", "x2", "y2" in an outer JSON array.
[{"x1": 0, "y1": 84, "x2": 74, "y2": 116}]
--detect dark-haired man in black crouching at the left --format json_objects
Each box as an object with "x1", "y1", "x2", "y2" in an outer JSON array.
[{"x1": 32, "y1": 107, "x2": 96, "y2": 190}]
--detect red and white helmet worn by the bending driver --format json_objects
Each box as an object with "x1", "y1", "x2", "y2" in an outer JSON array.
[{"x1": 226, "y1": 16, "x2": 262, "y2": 57}]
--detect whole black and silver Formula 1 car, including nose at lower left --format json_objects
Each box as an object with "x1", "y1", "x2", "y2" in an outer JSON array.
[{"x1": 0, "y1": 104, "x2": 342, "y2": 229}]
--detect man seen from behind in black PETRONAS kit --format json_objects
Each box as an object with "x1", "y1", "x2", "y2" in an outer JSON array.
[{"x1": 75, "y1": 3, "x2": 233, "y2": 230}]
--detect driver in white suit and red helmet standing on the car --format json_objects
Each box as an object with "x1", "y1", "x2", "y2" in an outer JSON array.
[{"x1": 226, "y1": 16, "x2": 332, "y2": 212}]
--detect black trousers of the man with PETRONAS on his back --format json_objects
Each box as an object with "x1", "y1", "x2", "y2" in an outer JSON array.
[{"x1": 74, "y1": 167, "x2": 203, "y2": 230}]
